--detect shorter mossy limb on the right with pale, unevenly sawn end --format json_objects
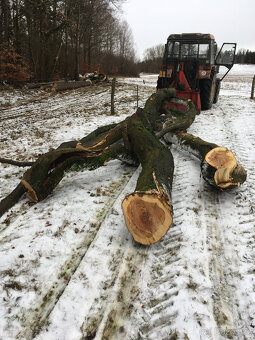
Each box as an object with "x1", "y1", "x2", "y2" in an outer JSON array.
[{"x1": 164, "y1": 132, "x2": 247, "y2": 190}]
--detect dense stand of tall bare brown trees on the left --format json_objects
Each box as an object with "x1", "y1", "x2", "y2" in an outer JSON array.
[{"x1": 0, "y1": 0, "x2": 137, "y2": 81}]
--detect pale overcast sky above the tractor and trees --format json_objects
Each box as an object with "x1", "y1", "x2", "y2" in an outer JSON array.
[{"x1": 123, "y1": 0, "x2": 255, "y2": 58}]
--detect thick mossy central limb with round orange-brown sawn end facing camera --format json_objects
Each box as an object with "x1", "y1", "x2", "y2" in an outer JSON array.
[{"x1": 122, "y1": 109, "x2": 174, "y2": 245}]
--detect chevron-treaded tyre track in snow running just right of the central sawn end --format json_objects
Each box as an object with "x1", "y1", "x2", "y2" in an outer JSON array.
[{"x1": 135, "y1": 150, "x2": 215, "y2": 339}]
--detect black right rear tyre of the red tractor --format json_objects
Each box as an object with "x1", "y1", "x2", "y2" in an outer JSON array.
[{"x1": 199, "y1": 70, "x2": 216, "y2": 110}]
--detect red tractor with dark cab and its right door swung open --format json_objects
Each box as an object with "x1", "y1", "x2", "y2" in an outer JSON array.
[{"x1": 157, "y1": 33, "x2": 236, "y2": 113}]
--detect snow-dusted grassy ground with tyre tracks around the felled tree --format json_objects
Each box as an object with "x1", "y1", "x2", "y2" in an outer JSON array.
[{"x1": 0, "y1": 65, "x2": 255, "y2": 340}]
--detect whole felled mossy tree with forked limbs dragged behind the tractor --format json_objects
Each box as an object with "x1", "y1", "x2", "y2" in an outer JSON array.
[{"x1": 0, "y1": 89, "x2": 246, "y2": 245}]
